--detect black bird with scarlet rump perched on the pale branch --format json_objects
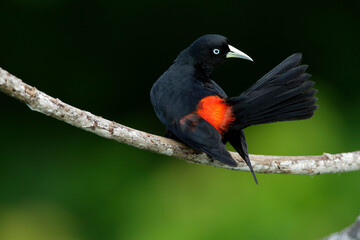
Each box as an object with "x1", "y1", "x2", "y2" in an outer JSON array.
[{"x1": 150, "y1": 34, "x2": 318, "y2": 184}]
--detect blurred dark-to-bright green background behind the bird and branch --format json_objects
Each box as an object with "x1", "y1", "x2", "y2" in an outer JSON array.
[{"x1": 0, "y1": 0, "x2": 360, "y2": 240}]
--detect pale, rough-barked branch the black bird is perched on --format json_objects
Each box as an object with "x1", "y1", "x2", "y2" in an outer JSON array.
[{"x1": 0, "y1": 68, "x2": 360, "y2": 175}]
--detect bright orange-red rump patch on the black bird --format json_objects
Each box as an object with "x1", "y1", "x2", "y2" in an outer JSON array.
[{"x1": 196, "y1": 96, "x2": 235, "y2": 135}]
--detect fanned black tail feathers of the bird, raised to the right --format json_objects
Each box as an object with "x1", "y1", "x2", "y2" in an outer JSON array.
[{"x1": 227, "y1": 53, "x2": 318, "y2": 130}]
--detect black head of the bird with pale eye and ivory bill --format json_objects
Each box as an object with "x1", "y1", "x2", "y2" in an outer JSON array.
[{"x1": 178, "y1": 34, "x2": 253, "y2": 74}]
